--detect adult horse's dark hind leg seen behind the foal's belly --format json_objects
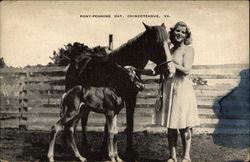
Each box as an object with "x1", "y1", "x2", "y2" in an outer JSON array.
[{"x1": 81, "y1": 109, "x2": 92, "y2": 152}]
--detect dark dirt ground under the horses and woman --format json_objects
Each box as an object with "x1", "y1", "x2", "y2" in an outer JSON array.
[{"x1": 0, "y1": 129, "x2": 249, "y2": 162}]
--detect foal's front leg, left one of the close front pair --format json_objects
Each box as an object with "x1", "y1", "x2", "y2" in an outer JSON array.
[{"x1": 105, "y1": 110, "x2": 116, "y2": 162}]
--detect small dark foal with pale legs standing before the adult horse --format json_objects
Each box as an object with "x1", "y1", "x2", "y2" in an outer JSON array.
[{"x1": 48, "y1": 68, "x2": 144, "y2": 161}]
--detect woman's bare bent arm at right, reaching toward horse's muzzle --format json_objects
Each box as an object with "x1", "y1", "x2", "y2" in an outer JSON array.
[{"x1": 174, "y1": 47, "x2": 194, "y2": 75}]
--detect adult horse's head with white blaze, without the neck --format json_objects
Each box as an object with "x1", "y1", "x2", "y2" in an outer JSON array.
[{"x1": 143, "y1": 23, "x2": 174, "y2": 77}]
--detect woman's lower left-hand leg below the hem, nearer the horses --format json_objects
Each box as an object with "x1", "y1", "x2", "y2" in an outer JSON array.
[{"x1": 168, "y1": 128, "x2": 178, "y2": 161}]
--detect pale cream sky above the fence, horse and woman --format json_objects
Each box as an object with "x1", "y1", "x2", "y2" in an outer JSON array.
[{"x1": 0, "y1": 1, "x2": 249, "y2": 67}]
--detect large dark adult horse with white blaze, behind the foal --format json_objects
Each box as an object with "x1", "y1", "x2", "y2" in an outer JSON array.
[{"x1": 66, "y1": 23, "x2": 174, "y2": 157}]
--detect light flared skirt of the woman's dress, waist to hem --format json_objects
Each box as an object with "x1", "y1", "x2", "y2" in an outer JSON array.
[{"x1": 154, "y1": 66, "x2": 200, "y2": 129}]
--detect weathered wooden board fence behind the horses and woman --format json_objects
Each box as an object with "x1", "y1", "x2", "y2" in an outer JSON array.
[{"x1": 0, "y1": 64, "x2": 249, "y2": 134}]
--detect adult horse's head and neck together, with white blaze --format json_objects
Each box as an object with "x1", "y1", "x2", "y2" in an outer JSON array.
[{"x1": 109, "y1": 23, "x2": 175, "y2": 77}]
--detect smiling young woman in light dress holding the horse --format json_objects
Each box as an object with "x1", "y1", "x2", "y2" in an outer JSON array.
[{"x1": 163, "y1": 22, "x2": 199, "y2": 162}]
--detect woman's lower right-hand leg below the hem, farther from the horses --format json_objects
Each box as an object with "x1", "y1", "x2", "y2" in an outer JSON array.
[{"x1": 180, "y1": 127, "x2": 192, "y2": 161}]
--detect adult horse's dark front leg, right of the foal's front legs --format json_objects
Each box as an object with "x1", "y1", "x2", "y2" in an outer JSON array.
[{"x1": 125, "y1": 96, "x2": 136, "y2": 157}]
